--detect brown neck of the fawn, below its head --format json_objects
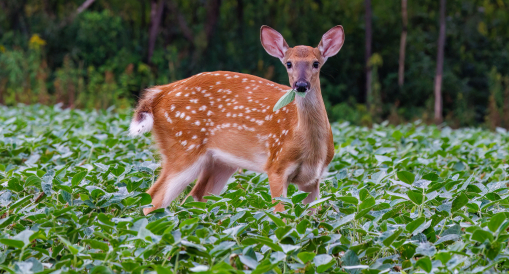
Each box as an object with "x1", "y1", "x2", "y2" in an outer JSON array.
[{"x1": 296, "y1": 84, "x2": 330, "y2": 158}]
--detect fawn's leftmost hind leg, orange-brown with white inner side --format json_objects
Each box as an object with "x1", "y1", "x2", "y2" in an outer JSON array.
[{"x1": 143, "y1": 153, "x2": 208, "y2": 215}]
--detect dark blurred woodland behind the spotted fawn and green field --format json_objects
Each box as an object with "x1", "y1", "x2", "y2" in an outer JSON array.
[{"x1": 0, "y1": 0, "x2": 509, "y2": 129}]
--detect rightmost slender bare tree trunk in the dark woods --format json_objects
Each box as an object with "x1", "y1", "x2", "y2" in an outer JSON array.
[{"x1": 435, "y1": 0, "x2": 446, "y2": 124}]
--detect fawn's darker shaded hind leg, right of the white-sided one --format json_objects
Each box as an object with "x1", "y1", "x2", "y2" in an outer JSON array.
[{"x1": 190, "y1": 160, "x2": 237, "y2": 201}]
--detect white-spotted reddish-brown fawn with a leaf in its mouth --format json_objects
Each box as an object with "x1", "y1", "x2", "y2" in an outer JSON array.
[{"x1": 129, "y1": 25, "x2": 345, "y2": 215}]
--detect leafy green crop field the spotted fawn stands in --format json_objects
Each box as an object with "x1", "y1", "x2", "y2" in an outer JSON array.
[{"x1": 0, "y1": 105, "x2": 509, "y2": 274}]
